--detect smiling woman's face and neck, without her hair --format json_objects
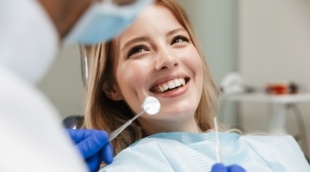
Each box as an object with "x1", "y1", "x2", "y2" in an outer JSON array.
[{"x1": 114, "y1": 5, "x2": 203, "y2": 133}]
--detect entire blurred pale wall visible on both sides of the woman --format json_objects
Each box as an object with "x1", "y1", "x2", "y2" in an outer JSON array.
[{"x1": 39, "y1": 0, "x2": 310, "y2": 155}]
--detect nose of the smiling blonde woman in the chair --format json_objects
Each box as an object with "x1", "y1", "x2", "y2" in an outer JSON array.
[{"x1": 155, "y1": 49, "x2": 178, "y2": 70}]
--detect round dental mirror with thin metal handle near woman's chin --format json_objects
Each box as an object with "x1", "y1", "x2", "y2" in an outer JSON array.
[{"x1": 109, "y1": 96, "x2": 160, "y2": 141}]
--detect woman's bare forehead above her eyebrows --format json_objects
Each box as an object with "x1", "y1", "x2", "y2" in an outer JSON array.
[{"x1": 118, "y1": 4, "x2": 183, "y2": 46}]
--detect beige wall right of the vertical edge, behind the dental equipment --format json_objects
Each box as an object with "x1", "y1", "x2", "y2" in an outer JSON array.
[{"x1": 239, "y1": 0, "x2": 310, "y2": 156}]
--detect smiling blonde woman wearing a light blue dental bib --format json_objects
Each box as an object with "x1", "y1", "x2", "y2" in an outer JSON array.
[{"x1": 81, "y1": 0, "x2": 309, "y2": 171}]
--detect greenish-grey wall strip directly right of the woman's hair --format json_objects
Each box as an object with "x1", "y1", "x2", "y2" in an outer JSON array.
[{"x1": 180, "y1": 0, "x2": 239, "y2": 127}]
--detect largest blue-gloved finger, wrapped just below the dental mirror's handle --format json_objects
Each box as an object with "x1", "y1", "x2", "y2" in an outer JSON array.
[{"x1": 76, "y1": 130, "x2": 109, "y2": 159}]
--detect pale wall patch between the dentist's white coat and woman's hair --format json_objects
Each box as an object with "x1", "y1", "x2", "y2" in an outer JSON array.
[{"x1": 39, "y1": 45, "x2": 85, "y2": 118}]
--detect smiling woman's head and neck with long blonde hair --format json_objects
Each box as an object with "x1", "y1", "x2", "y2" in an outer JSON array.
[{"x1": 85, "y1": 1, "x2": 218, "y2": 153}]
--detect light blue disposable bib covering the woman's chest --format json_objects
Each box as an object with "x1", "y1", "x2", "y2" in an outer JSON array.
[{"x1": 100, "y1": 132, "x2": 310, "y2": 172}]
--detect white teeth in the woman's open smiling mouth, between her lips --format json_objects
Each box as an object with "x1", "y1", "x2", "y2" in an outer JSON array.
[{"x1": 150, "y1": 78, "x2": 189, "y2": 93}]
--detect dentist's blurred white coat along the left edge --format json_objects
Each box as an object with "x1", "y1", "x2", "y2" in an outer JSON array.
[{"x1": 0, "y1": 0, "x2": 87, "y2": 172}]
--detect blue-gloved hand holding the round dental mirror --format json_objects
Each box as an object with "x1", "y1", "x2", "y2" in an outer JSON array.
[{"x1": 66, "y1": 129, "x2": 114, "y2": 172}]
